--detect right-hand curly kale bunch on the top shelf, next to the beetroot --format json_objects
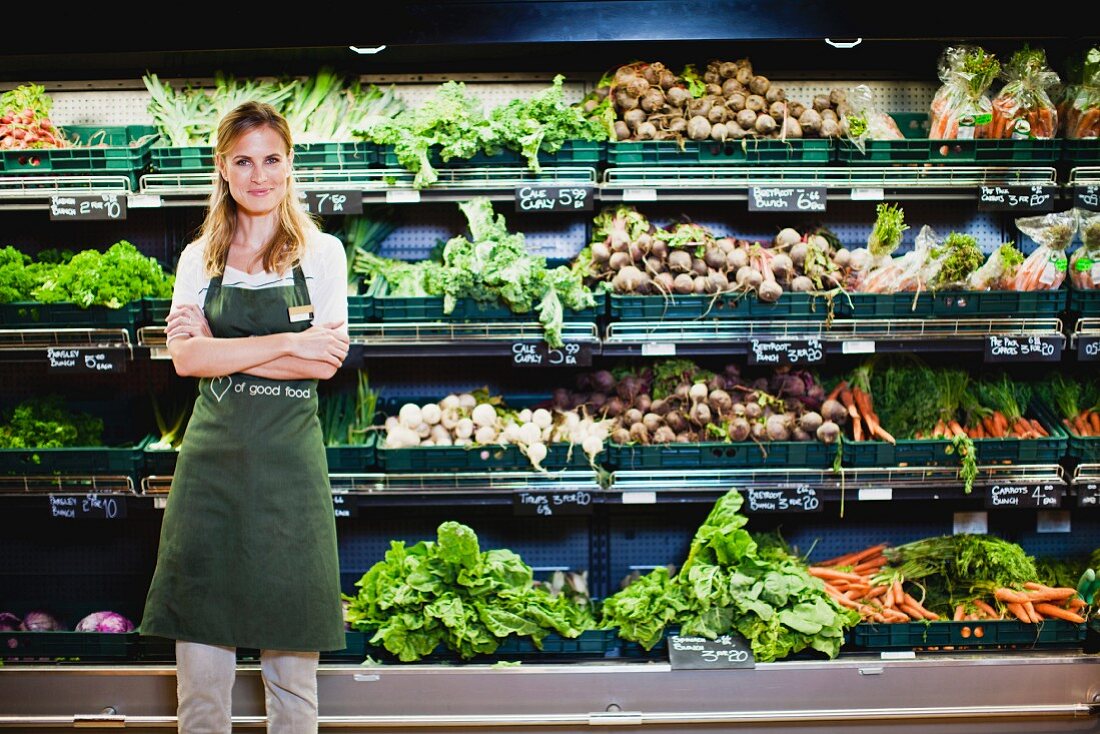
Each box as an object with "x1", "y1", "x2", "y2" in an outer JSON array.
[{"x1": 490, "y1": 74, "x2": 608, "y2": 172}]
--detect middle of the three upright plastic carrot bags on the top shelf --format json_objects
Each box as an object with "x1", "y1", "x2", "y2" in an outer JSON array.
[{"x1": 989, "y1": 46, "x2": 1059, "y2": 140}]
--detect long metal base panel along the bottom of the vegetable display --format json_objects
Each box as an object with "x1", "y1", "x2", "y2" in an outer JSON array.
[{"x1": 0, "y1": 649, "x2": 1100, "y2": 734}]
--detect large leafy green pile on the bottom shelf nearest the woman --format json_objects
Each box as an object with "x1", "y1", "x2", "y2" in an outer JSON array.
[{"x1": 344, "y1": 522, "x2": 595, "y2": 661}]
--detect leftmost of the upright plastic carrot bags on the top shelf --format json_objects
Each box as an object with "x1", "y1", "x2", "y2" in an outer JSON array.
[{"x1": 928, "y1": 45, "x2": 1001, "y2": 140}]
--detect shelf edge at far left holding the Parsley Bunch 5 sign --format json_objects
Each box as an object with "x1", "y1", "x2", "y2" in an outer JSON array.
[{"x1": 0, "y1": 329, "x2": 134, "y2": 371}]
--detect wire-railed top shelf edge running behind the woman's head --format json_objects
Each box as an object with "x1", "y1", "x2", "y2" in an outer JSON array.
[{"x1": 140, "y1": 166, "x2": 596, "y2": 206}]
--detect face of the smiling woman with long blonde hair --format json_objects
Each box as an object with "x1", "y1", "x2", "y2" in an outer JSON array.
[{"x1": 218, "y1": 125, "x2": 292, "y2": 215}]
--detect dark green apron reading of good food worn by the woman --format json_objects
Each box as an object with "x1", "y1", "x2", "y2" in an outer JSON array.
[{"x1": 140, "y1": 265, "x2": 345, "y2": 651}]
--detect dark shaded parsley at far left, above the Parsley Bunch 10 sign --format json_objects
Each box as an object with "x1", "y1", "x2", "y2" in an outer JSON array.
[{"x1": 0, "y1": 395, "x2": 103, "y2": 449}]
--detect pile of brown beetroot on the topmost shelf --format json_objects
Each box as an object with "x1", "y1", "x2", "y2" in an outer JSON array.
[{"x1": 582, "y1": 58, "x2": 848, "y2": 141}]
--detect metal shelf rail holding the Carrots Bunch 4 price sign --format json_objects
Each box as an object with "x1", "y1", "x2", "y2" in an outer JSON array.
[{"x1": 606, "y1": 464, "x2": 1067, "y2": 513}]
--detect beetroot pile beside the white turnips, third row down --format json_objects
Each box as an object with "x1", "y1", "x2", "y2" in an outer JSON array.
[{"x1": 553, "y1": 360, "x2": 840, "y2": 445}]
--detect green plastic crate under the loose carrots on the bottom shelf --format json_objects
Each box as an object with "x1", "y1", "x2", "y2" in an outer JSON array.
[{"x1": 851, "y1": 620, "x2": 1087, "y2": 650}]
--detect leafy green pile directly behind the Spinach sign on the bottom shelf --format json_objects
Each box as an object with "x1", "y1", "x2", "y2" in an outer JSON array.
[{"x1": 602, "y1": 491, "x2": 859, "y2": 661}]
